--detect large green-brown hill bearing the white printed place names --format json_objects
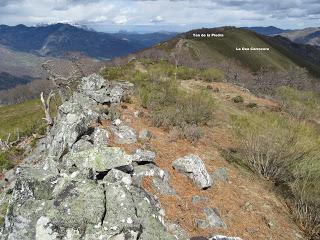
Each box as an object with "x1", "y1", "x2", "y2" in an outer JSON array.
[{"x1": 146, "y1": 27, "x2": 320, "y2": 83}]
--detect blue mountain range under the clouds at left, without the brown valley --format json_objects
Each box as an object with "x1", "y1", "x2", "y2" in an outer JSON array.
[{"x1": 0, "y1": 23, "x2": 176, "y2": 59}]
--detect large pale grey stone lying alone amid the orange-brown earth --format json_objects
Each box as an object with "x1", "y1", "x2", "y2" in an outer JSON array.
[{"x1": 172, "y1": 155, "x2": 212, "y2": 189}]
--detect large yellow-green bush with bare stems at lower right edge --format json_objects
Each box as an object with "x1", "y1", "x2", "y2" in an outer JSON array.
[{"x1": 232, "y1": 112, "x2": 320, "y2": 239}]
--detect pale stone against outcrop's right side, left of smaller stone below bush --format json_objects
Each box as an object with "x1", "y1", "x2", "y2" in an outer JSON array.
[{"x1": 110, "y1": 125, "x2": 137, "y2": 144}]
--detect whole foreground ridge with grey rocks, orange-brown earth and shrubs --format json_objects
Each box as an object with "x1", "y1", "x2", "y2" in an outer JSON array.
[{"x1": 0, "y1": 59, "x2": 320, "y2": 240}]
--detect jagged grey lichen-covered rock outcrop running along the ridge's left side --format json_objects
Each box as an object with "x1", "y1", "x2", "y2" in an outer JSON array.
[{"x1": 0, "y1": 74, "x2": 178, "y2": 240}]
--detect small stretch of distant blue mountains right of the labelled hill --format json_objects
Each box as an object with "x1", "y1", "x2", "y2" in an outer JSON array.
[{"x1": 244, "y1": 26, "x2": 320, "y2": 47}]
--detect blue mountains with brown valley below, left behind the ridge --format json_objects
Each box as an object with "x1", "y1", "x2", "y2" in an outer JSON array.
[{"x1": 0, "y1": 23, "x2": 176, "y2": 90}]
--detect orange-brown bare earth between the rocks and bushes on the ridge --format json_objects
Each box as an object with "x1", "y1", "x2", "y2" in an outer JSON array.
[{"x1": 103, "y1": 83, "x2": 303, "y2": 240}]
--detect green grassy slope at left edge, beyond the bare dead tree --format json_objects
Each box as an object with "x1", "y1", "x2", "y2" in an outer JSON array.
[{"x1": 0, "y1": 99, "x2": 44, "y2": 139}]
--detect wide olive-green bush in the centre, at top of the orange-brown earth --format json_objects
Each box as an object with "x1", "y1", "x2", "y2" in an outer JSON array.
[{"x1": 139, "y1": 79, "x2": 214, "y2": 131}]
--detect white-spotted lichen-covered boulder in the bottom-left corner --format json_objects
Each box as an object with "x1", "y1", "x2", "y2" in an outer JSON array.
[{"x1": 1, "y1": 167, "x2": 58, "y2": 240}]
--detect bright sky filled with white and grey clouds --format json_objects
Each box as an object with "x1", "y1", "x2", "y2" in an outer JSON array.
[{"x1": 0, "y1": 0, "x2": 320, "y2": 32}]
